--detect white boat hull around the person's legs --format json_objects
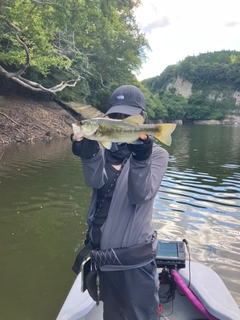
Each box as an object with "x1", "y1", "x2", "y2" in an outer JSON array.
[{"x1": 57, "y1": 262, "x2": 240, "y2": 320}]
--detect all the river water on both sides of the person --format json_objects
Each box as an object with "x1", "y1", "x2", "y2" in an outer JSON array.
[{"x1": 0, "y1": 126, "x2": 240, "y2": 320}]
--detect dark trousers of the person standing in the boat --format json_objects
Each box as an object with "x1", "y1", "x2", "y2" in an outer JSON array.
[{"x1": 100, "y1": 262, "x2": 159, "y2": 320}]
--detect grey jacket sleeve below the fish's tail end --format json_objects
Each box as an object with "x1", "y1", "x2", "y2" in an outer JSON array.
[{"x1": 128, "y1": 145, "x2": 168, "y2": 204}]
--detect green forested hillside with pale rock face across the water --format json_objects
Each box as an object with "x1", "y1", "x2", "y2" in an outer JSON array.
[{"x1": 142, "y1": 51, "x2": 240, "y2": 122}]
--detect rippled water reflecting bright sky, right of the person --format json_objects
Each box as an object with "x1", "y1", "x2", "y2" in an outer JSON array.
[{"x1": 153, "y1": 126, "x2": 240, "y2": 304}]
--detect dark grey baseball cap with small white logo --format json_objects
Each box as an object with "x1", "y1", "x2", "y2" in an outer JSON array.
[{"x1": 106, "y1": 85, "x2": 146, "y2": 116}]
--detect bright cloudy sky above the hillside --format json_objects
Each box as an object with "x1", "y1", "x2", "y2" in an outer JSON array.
[{"x1": 135, "y1": 0, "x2": 240, "y2": 81}]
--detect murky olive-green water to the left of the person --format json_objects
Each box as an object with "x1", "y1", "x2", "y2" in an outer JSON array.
[{"x1": 0, "y1": 140, "x2": 91, "y2": 320}]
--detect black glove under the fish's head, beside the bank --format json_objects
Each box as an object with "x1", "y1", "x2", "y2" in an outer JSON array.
[{"x1": 71, "y1": 137, "x2": 100, "y2": 159}]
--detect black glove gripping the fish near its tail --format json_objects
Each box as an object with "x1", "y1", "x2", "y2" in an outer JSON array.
[{"x1": 127, "y1": 136, "x2": 153, "y2": 161}]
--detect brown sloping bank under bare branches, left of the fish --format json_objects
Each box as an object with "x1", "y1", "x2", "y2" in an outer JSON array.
[{"x1": 0, "y1": 96, "x2": 76, "y2": 147}]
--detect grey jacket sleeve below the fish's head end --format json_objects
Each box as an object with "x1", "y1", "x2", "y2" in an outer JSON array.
[{"x1": 82, "y1": 147, "x2": 106, "y2": 189}]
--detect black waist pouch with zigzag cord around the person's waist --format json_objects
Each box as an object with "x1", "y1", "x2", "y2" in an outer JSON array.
[{"x1": 90, "y1": 231, "x2": 157, "y2": 268}]
